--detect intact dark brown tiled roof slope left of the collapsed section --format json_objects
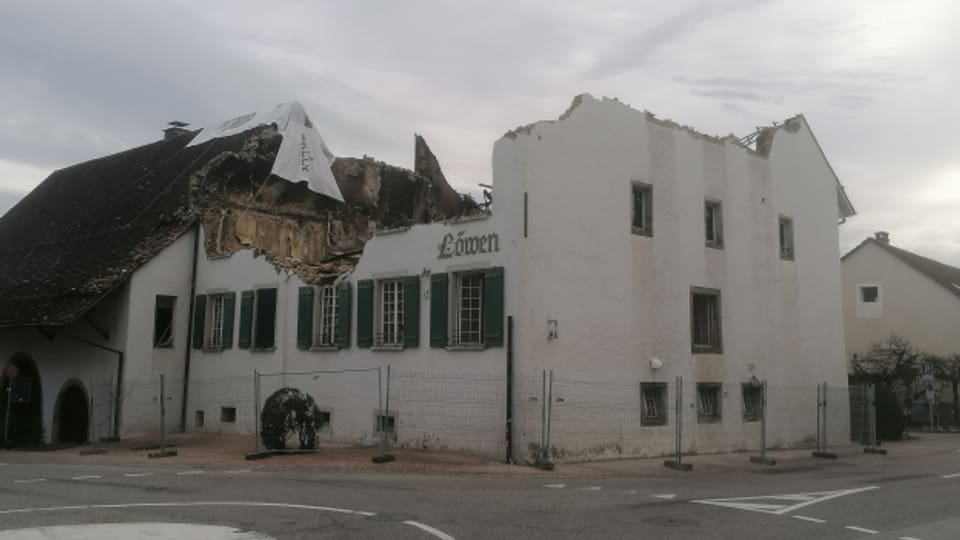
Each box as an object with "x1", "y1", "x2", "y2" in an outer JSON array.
[{"x1": 0, "y1": 132, "x2": 274, "y2": 326}]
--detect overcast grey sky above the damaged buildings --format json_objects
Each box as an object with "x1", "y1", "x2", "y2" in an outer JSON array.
[{"x1": 0, "y1": 0, "x2": 960, "y2": 266}]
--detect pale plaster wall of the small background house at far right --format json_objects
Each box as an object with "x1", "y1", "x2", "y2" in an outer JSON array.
[{"x1": 842, "y1": 242, "x2": 960, "y2": 358}]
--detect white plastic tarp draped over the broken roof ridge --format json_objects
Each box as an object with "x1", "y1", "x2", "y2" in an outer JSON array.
[{"x1": 189, "y1": 102, "x2": 343, "y2": 202}]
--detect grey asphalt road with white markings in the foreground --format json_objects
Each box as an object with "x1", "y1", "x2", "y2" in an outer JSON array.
[{"x1": 0, "y1": 437, "x2": 960, "y2": 540}]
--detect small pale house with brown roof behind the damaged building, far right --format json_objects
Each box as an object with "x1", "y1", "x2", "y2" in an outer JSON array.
[{"x1": 841, "y1": 231, "x2": 960, "y2": 358}]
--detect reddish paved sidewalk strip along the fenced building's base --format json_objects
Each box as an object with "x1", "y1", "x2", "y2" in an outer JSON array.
[{"x1": 0, "y1": 433, "x2": 960, "y2": 478}]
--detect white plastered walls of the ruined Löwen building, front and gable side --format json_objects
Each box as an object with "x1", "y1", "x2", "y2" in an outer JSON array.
[{"x1": 0, "y1": 96, "x2": 849, "y2": 459}]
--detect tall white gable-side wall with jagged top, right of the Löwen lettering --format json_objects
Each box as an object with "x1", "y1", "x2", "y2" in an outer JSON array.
[{"x1": 494, "y1": 97, "x2": 847, "y2": 454}]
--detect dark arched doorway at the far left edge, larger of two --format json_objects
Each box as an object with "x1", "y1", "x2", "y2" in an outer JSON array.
[{"x1": 0, "y1": 353, "x2": 44, "y2": 448}]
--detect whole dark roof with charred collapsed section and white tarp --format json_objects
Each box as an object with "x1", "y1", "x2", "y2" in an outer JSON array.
[{"x1": 0, "y1": 105, "x2": 475, "y2": 327}]
